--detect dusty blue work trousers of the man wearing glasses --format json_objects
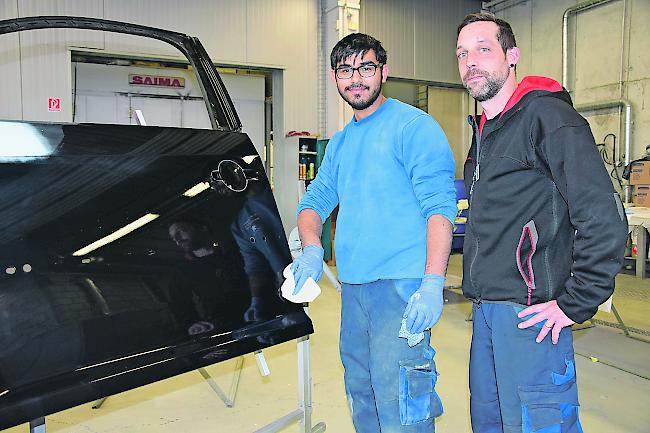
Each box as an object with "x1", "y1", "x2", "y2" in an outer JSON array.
[{"x1": 340, "y1": 279, "x2": 442, "y2": 433}]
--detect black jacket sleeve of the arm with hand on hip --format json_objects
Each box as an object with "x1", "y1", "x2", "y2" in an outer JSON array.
[{"x1": 540, "y1": 120, "x2": 627, "y2": 323}]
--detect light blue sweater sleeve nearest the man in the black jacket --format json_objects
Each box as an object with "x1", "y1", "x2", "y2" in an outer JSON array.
[{"x1": 402, "y1": 115, "x2": 458, "y2": 225}]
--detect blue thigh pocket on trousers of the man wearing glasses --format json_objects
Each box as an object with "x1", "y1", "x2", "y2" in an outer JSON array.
[{"x1": 399, "y1": 347, "x2": 443, "y2": 425}]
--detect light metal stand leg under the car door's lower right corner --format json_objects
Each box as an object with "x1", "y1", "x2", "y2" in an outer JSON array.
[{"x1": 254, "y1": 308, "x2": 326, "y2": 433}]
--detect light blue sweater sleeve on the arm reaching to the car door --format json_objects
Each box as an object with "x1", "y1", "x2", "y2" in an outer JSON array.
[{"x1": 296, "y1": 138, "x2": 339, "y2": 223}]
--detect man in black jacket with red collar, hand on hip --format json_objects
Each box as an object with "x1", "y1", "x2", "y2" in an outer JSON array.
[{"x1": 456, "y1": 13, "x2": 627, "y2": 433}]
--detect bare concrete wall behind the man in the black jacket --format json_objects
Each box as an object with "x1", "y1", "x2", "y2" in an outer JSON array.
[{"x1": 497, "y1": 0, "x2": 650, "y2": 164}]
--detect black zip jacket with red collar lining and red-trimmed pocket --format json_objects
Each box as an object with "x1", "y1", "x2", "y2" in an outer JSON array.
[{"x1": 463, "y1": 77, "x2": 627, "y2": 323}]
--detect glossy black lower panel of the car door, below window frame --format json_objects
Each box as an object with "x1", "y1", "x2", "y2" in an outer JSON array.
[{"x1": 0, "y1": 122, "x2": 313, "y2": 429}]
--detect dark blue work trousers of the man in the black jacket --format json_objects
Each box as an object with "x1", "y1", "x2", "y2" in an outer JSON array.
[{"x1": 469, "y1": 303, "x2": 582, "y2": 433}]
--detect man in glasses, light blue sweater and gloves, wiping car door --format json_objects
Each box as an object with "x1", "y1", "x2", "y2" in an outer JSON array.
[{"x1": 293, "y1": 34, "x2": 456, "y2": 433}]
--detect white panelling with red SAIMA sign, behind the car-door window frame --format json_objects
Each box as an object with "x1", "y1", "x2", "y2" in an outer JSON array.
[{"x1": 72, "y1": 62, "x2": 264, "y2": 154}]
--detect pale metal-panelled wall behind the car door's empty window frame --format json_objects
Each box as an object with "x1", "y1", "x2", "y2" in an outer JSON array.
[{"x1": 0, "y1": 0, "x2": 318, "y2": 131}]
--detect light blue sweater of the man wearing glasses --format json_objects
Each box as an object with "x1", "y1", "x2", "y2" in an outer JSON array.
[{"x1": 298, "y1": 99, "x2": 457, "y2": 284}]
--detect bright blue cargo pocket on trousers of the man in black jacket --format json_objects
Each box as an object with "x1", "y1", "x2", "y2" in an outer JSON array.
[{"x1": 519, "y1": 360, "x2": 579, "y2": 433}]
